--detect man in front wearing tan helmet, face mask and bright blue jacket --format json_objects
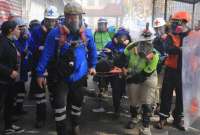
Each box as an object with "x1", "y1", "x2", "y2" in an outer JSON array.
[{"x1": 37, "y1": 2, "x2": 97, "y2": 135}]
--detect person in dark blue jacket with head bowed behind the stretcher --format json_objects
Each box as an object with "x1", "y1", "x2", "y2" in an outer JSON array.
[{"x1": 93, "y1": 29, "x2": 131, "y2": 118}]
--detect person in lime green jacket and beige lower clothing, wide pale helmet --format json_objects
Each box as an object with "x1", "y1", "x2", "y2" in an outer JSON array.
[{"x1": 124, "y1": 25, "x2": 159, "y2": 135}]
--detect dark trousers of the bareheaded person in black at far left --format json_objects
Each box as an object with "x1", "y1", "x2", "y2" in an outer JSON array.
[{"x1": 0, "y1": 83, "x2": 16, "y2": 129}]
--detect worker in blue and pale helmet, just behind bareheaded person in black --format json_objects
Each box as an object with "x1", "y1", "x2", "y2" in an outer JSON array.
[{"x1": 14, "y1": 18, "x2": 33, "y2": 115}]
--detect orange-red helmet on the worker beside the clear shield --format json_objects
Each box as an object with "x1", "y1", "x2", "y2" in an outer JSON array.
[{"x1": 172, "y1": 11, "x2": 191, "y2": 22}]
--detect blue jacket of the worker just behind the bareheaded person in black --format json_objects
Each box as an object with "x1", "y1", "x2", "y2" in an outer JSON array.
[{"x1": 14, "y1": 33, "x2": 33, "y2": 81}]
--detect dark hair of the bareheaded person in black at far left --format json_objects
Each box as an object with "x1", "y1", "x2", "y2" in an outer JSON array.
[{"x1": 1, "y1": 21, "x2": 17, "y2": 36}]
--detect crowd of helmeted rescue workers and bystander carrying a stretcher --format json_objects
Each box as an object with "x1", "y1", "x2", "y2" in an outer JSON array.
[{"x1": 0, "y1": 2, "x2": 197, "y2": 135}]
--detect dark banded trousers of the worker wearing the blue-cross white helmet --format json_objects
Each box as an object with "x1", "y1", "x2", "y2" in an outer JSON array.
[{"x1": 31, "y1": 77, "x2": 47, "y2": 121}]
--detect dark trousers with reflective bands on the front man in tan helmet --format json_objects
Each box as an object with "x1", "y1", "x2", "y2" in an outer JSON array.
[{"x1": 50, "y1": 81, "x2": 84, "y2": 135}]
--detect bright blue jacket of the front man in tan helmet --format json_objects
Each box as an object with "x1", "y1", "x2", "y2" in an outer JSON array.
[{"x1": 36, "y1": 27, "x2": 97, "y2": 82}]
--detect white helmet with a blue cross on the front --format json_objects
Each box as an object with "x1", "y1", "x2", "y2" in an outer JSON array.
[{"x1": 44, "y1": 6, "x2": 59, "y2": 19}]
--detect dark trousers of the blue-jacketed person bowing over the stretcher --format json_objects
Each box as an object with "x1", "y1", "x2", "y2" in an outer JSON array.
[{"x1": 111, "y1": 76, "x2": 126, "y2": 112}]
